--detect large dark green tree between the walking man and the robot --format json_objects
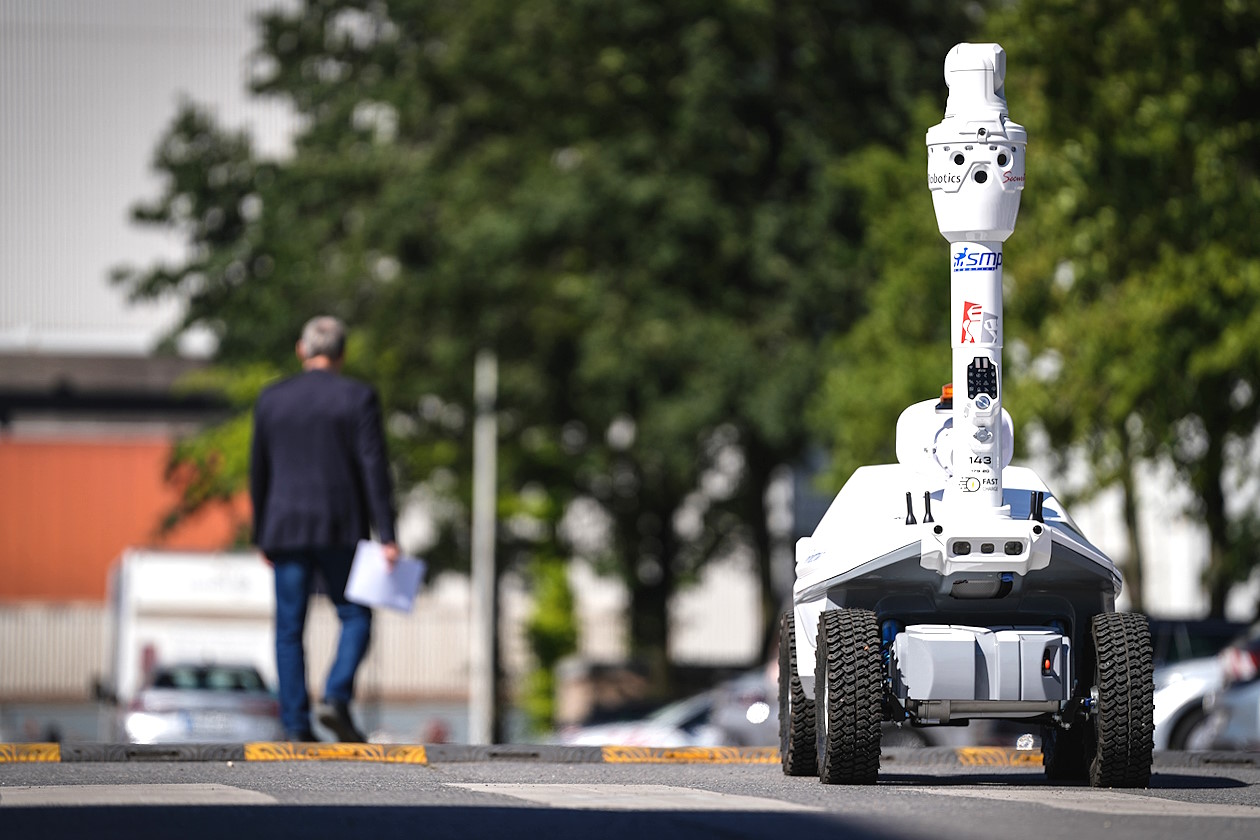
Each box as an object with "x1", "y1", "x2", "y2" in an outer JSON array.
[{"x1": 122, "y1": 0, "x2": 992, "y2": 683}]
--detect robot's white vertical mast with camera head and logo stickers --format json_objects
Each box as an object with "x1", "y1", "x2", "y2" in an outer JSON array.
[{"x1": 927, "y1": 44, "x2": 1028, "y2": 510}]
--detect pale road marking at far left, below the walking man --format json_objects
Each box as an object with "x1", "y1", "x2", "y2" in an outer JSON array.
[{"x1": 0, "y1": 785, "x2": 276, "y2": 809}]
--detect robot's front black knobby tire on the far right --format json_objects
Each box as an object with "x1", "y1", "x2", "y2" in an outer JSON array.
[{"x1": 1090, "y1": 612, "x2": 1155, "y2": 787}]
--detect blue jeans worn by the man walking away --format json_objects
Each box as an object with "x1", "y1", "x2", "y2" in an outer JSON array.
[{"x1": 267, "y1": 548, "x2": 372, "y2": 734}]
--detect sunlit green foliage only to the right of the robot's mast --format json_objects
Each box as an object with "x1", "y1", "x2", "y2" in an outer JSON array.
[{"x1": 993, "y1": 0, "x2": 1260, "y2": 616}]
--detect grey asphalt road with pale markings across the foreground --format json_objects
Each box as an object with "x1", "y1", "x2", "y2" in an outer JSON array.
[{"x1": 0, "y1": 751, "x2": 1260, "y2": 840}]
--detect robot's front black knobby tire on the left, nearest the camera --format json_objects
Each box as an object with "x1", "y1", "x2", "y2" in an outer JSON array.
[{"x1": 814, "y1": 610, "x2": 883, "y2": 785}]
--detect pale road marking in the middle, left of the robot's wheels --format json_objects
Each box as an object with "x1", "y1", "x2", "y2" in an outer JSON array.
[{"x1": 447, "y1": 783, "x2": 822, "y2": 812}]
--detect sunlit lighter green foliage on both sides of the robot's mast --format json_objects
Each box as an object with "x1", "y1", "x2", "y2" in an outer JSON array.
[{"x1": 811, "y1": 0, "x2": 1260, "y2": 615}]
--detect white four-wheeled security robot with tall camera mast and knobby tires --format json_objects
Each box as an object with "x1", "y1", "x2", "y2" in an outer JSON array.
[{"x1": 779, "y1": 44, "x2": 1154, "y2": 787}]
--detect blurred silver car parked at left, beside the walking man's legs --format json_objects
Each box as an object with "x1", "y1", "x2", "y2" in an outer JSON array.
[{"x1": 120, "y1": 664, "x2": 285, "y2": 744}]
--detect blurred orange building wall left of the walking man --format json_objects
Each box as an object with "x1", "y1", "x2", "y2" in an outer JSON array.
[{"x1": 0, "y1": 438, "x2": 249, "y2": 601}]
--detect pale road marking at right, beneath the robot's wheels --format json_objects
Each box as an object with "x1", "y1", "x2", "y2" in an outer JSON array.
[{"x1": 907, "y1": 787, "x2": 1260, "y2": 820}]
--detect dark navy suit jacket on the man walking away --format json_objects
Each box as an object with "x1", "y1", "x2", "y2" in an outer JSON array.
[{"x1": 249, "y1": 370, "x2": 394, "y2": 553}]
